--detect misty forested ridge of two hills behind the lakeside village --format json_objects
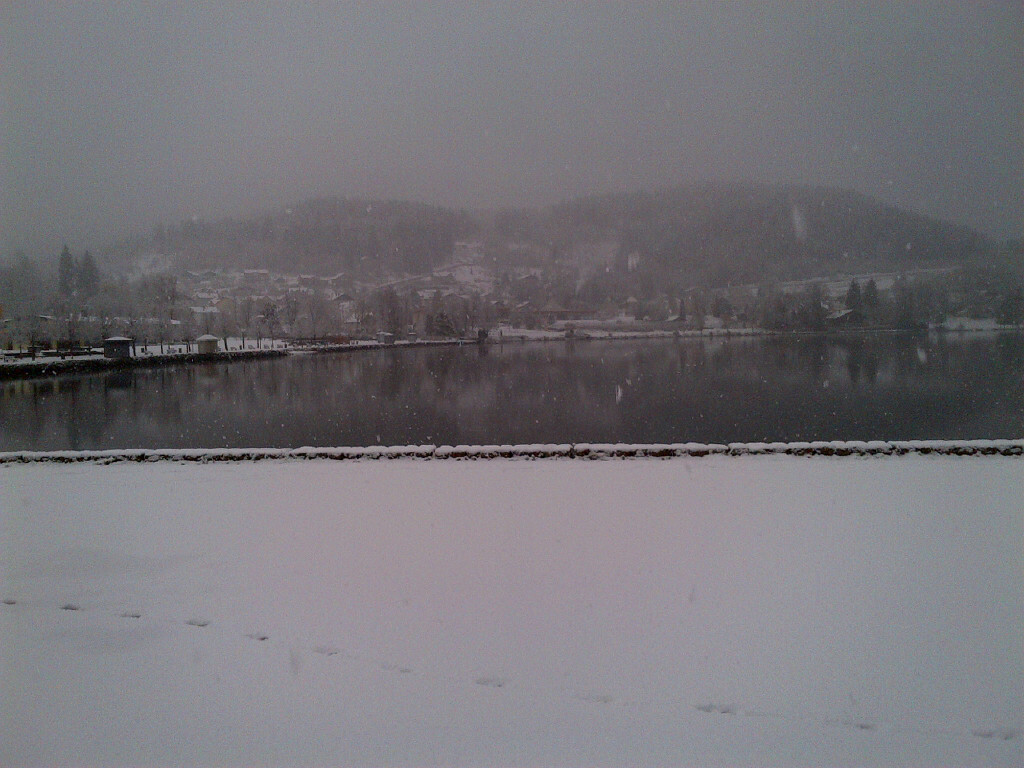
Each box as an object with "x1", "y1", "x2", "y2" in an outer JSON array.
[{"x1": 114, "y1": 183, "x2": 999, "y2": 287}]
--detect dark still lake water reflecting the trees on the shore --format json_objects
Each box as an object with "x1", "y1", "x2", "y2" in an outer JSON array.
[{"x1": 0, "y1": 335, "x2": 1024, "y2": 451}]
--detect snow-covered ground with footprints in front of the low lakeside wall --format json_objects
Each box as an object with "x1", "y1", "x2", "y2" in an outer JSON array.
[{"x1": 0, "y1": 455, "x2": 1024, "y2": 766}]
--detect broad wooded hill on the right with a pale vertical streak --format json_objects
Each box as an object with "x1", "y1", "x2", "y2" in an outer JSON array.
[{"x1": 551, "y1": 184, "x2": 997, "y2": 286}]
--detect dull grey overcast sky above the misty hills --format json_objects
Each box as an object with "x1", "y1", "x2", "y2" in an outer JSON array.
[{"x1": 0, "y1": 0, "x2": 1024, "y2": 253}]
